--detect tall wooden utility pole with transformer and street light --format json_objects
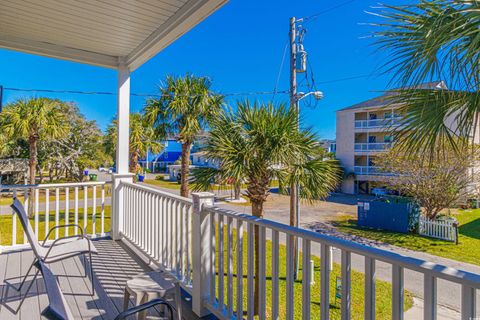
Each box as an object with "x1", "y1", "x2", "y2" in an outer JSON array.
[{"x1": 290, "y1": 17, "x2": 300, "y2": 279}]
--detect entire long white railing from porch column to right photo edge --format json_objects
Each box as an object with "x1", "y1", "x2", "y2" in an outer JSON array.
[{"x1": 116, "y1": 182, "x2": 480, "y2": 320}]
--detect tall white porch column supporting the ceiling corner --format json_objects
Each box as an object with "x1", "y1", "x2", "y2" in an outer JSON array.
[{"x1": 111, "y1": 65, "x2": 133, "y2": 240}]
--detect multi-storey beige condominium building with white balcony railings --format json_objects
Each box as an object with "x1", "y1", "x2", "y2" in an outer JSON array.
[{"x1": 336, "y1": 81, "x2": 455, "y2": 194}]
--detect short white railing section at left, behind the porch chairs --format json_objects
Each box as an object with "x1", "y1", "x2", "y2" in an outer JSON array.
[{"x1": 0, "y1": 182, "x2": 111, "y2": 250}]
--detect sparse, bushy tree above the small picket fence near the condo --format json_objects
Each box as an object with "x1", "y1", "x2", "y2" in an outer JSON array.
[{"x1": 375, "y1": 146, "x2": 479, "y2": 219}]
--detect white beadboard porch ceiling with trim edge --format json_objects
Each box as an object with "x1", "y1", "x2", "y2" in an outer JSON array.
[{"x1": 0, "y1": 0, "x2": 228, "y2": 70}]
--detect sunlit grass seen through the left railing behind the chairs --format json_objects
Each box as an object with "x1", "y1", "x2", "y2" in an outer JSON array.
[{"x1": 0, "y1": 206, "x2": 110, "y2": 246}]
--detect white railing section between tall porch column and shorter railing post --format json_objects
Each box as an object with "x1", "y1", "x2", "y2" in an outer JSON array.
[{"x1": 121, "y1": 182, "x2": 193, "y2": 291}]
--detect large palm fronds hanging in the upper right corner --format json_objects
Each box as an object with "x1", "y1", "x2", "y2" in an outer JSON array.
[{"x1": 375, "y1": 0, "x2": 480, "y2": 152}]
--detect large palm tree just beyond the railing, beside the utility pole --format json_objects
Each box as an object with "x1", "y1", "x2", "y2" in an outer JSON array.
[{"x1": 193, "y1": 102, "x2": 340, "y2": 312}]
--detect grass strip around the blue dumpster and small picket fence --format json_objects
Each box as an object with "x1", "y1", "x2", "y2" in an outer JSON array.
[{"x1": 333, "y1": 209, "x2": 480, "y2": 265}]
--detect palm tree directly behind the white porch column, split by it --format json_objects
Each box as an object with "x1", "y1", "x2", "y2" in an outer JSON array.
[{"x1": 105, "y1": 113, "x2": 163, "y2": 178}]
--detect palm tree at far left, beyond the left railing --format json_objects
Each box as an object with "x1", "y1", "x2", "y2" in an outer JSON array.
[{"x1": 0, "y1": 98, "x2": 68, "y2": 184}]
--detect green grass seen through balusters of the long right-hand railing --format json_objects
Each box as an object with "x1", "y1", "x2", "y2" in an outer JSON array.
[{"x1": 215, "y1": 229, "x2": 413, "y2": 319}]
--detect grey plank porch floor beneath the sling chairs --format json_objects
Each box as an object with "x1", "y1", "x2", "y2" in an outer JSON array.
[{"x1": 0, "y1": 239, "x2": 210, "y2": 320}]
